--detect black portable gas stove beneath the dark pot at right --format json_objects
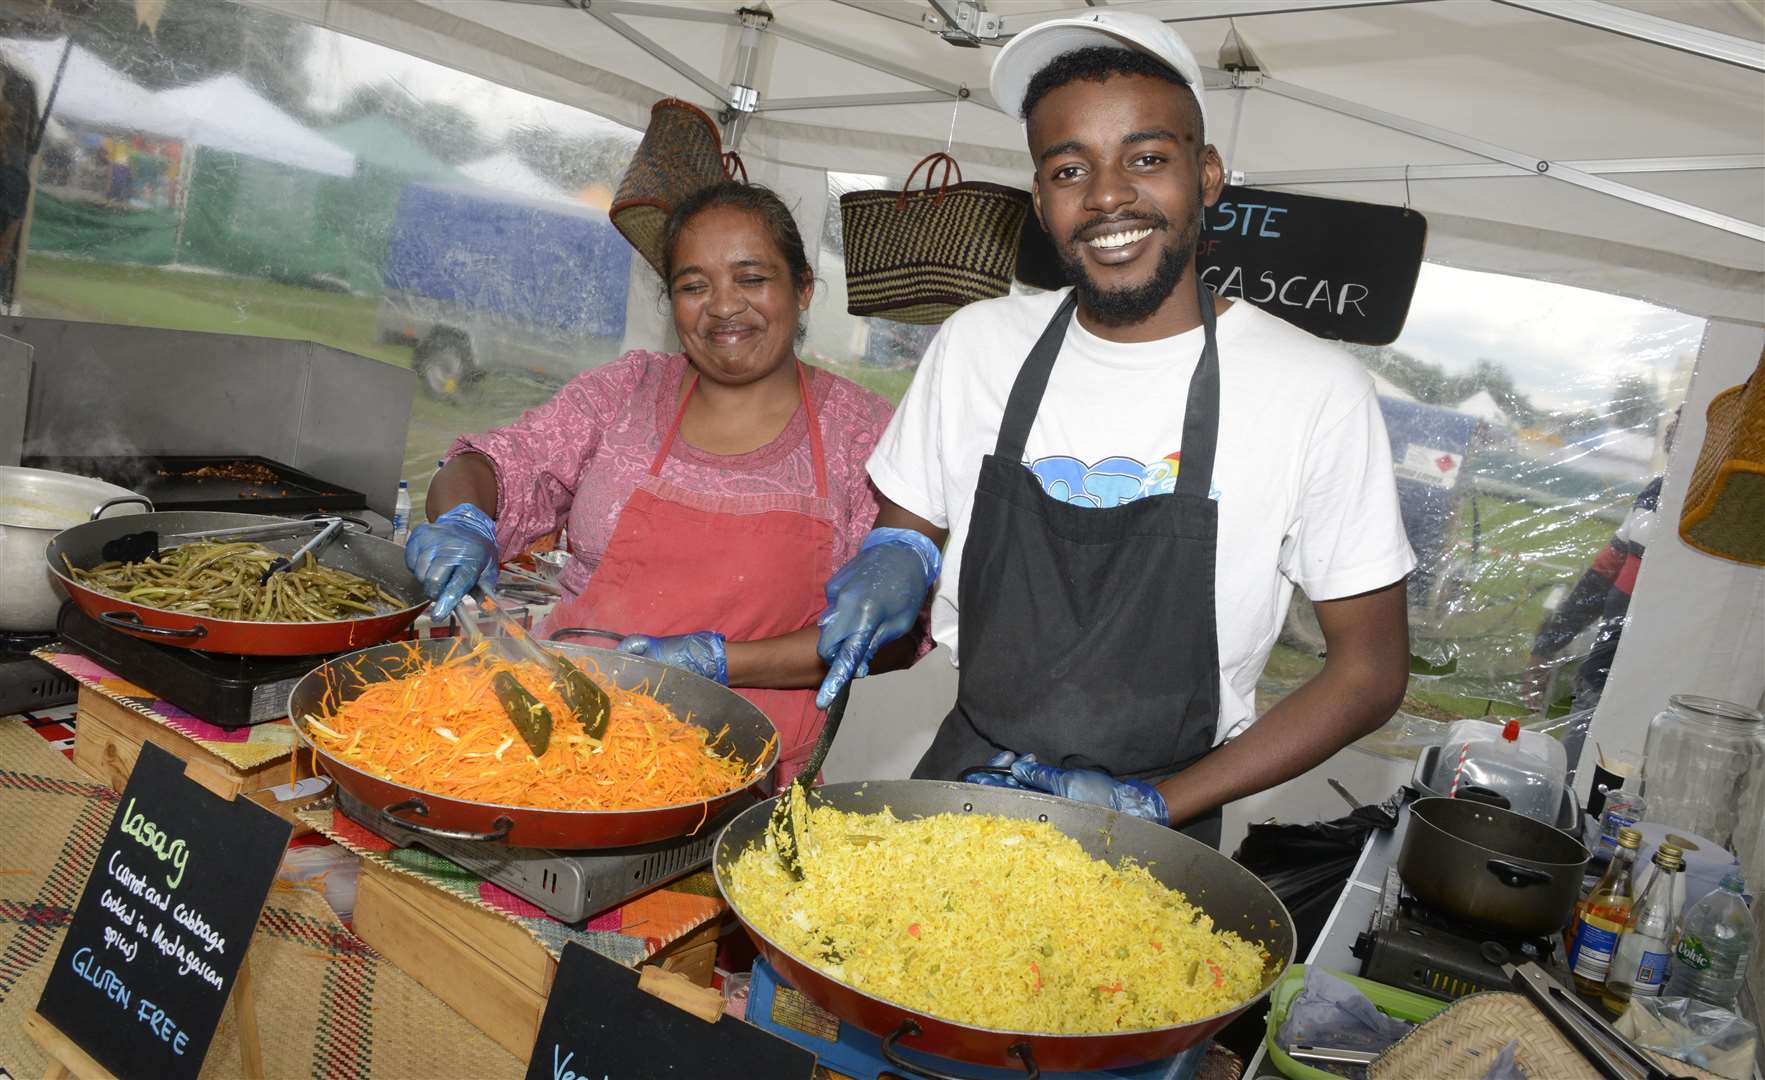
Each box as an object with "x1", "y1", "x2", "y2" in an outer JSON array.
[{"x1": 1352, "y1": 868, "x2": 1562, "y2": 1001}]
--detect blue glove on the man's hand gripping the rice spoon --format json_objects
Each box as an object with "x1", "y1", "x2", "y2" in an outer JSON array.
[{"x1": 815, "y1": 529, "x2": 943, "y2": 709}]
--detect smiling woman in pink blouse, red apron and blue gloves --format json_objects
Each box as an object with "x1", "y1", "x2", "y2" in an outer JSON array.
[{"x1": 404, "y1": 182, "x2": 913, "y2": 784}]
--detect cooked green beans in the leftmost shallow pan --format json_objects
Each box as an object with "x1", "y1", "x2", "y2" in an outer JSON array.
[{"x1": 62, "y1": 540, "x2": 404, "y2": 623}]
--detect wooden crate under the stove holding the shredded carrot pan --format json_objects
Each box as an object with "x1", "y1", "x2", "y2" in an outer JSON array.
[{"x1": 355, "y1": 859, "x2": 720, "y2": 1061}]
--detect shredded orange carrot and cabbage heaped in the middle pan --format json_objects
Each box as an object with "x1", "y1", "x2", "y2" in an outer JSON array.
[{"x1": 305, "y1": 646, "x2": 766, "y2": 810}]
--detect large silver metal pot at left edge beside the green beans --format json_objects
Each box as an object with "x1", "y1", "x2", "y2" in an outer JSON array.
[{"x1": 0, "y1": 466, "x2": 154, "y2": 634}]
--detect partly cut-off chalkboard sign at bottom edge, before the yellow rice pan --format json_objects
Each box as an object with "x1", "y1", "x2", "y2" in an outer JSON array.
[{"x1": 528, "y1": 942, "x2": 815, "y2": 1080}]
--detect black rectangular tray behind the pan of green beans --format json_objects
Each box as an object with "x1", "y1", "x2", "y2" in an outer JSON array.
[{"x1": 23, "y1": 454, "x2": 367, "y2": 514}]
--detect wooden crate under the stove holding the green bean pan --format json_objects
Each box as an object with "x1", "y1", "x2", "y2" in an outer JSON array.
[{"x1": 74, "y1": 686, "x2": 325, "y2": 836}]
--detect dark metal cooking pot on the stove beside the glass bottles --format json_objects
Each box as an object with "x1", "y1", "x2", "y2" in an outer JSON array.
[{"x1": 1398, "y1": 798, "x2": 1590, "y2": 937}]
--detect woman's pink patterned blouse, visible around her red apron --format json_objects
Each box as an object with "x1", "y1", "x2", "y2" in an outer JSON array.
[{"x1": 448, "y1": 349, "x2": 891, "y2": 603}]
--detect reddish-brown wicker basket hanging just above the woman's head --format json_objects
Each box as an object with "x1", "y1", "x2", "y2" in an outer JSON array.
[{"x1": 607, "y1": 97, "x2": 724, "y2": 274}]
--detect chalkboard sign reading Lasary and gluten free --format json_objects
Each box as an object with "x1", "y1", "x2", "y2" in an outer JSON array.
[{"x1": 37, "y1": 743, "x2": 293, "y2": 1080}]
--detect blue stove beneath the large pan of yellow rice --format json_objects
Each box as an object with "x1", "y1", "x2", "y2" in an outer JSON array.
[{"x1": 743, "y1": 958, "x2": 1200, "y2": 1080}]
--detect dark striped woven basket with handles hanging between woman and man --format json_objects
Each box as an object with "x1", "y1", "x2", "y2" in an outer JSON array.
[{"x1": 840, "y1": 154, "x2": 1029, "y2": 326}]
